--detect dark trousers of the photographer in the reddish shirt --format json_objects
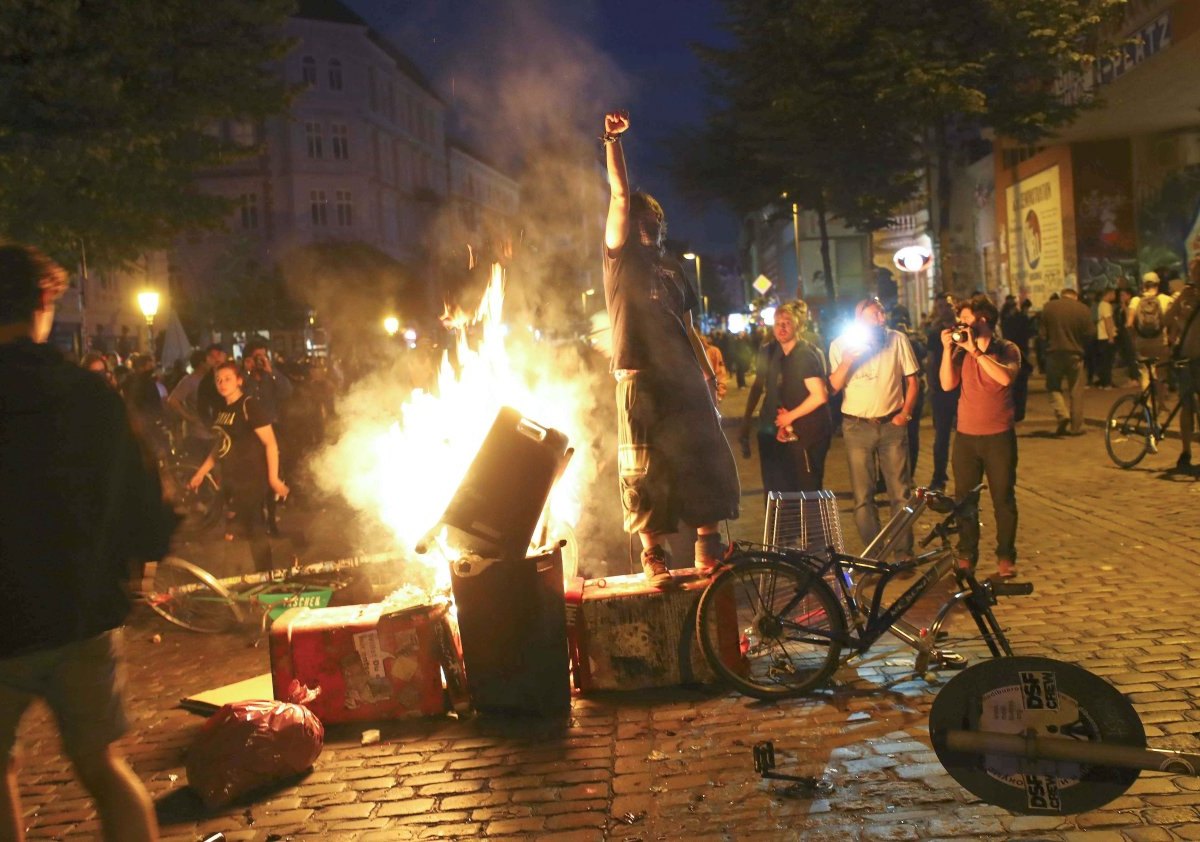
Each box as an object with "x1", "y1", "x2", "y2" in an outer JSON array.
[{"x1": 954, "y1": 429, "x2": 1016, "y2": 564}]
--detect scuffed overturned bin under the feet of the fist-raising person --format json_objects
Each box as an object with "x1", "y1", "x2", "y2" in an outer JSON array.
[{"x1": 566, "y1": 567, "x2": 737, "y2": 692}]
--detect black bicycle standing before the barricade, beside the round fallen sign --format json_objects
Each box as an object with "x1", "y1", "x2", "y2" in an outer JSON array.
[{"x1": 696, "y1": 486, "x2": 1033, "y2": 699}]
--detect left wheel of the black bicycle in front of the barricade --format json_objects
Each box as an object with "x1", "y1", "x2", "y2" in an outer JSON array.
[{"x1": 696, "y1": 557, "x2": 846, "y2": 699}]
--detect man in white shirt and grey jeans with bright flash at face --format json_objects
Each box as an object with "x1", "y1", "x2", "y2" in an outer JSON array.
[{"x1": 829, "y1": 299, "x2": 920, "y2": 559}]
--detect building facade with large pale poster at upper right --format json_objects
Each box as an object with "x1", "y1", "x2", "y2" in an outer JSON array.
[{"x1": 992, "y1": 0, "x2": 1200, "y2": 306}]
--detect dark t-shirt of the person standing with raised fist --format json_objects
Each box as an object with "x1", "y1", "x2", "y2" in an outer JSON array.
[{"x1": 604, "y1": 240, "x2": 698, "y2": 372}]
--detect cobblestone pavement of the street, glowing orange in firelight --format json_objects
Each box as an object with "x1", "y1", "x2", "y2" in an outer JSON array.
[{"x1": 11, "y1": 383, "x2": 1200, "y2": 842}]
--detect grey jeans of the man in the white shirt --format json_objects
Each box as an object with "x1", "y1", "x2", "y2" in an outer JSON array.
[{"x1": 841, "y1": 416, "x2": 912, "y2": 558}]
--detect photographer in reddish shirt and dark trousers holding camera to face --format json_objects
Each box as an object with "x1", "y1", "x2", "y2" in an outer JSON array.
[{"x1": 938, "y1": 295, "x2": 1021, "y2": 579}]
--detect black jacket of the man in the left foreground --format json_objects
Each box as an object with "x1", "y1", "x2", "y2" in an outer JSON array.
[{"x1": 0, "y1": 341, "x2": 175, "y2": 658}]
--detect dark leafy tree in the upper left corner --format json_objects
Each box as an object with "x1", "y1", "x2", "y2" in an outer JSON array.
[{"x1": 0, "y1": 0, "x2": 294, "y2": 266}]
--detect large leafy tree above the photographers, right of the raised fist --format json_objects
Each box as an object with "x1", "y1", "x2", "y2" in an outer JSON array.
[{"x1": 678, "y1": 0, "x2": 1124, "y2": 294}]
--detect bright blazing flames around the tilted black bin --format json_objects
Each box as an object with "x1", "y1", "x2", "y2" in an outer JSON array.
[{"x1": 318, "y1": 264, "x2": 596, "y2": 588}]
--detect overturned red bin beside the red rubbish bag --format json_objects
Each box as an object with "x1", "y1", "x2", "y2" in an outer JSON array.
[{"x1": 270, "y1": 602, "x2": 457, "y2": 722}]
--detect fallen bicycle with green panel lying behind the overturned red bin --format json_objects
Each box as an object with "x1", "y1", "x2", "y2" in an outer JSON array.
[{"x1": 142, "y1": 553, "x2": 396, "y2": 634}]
